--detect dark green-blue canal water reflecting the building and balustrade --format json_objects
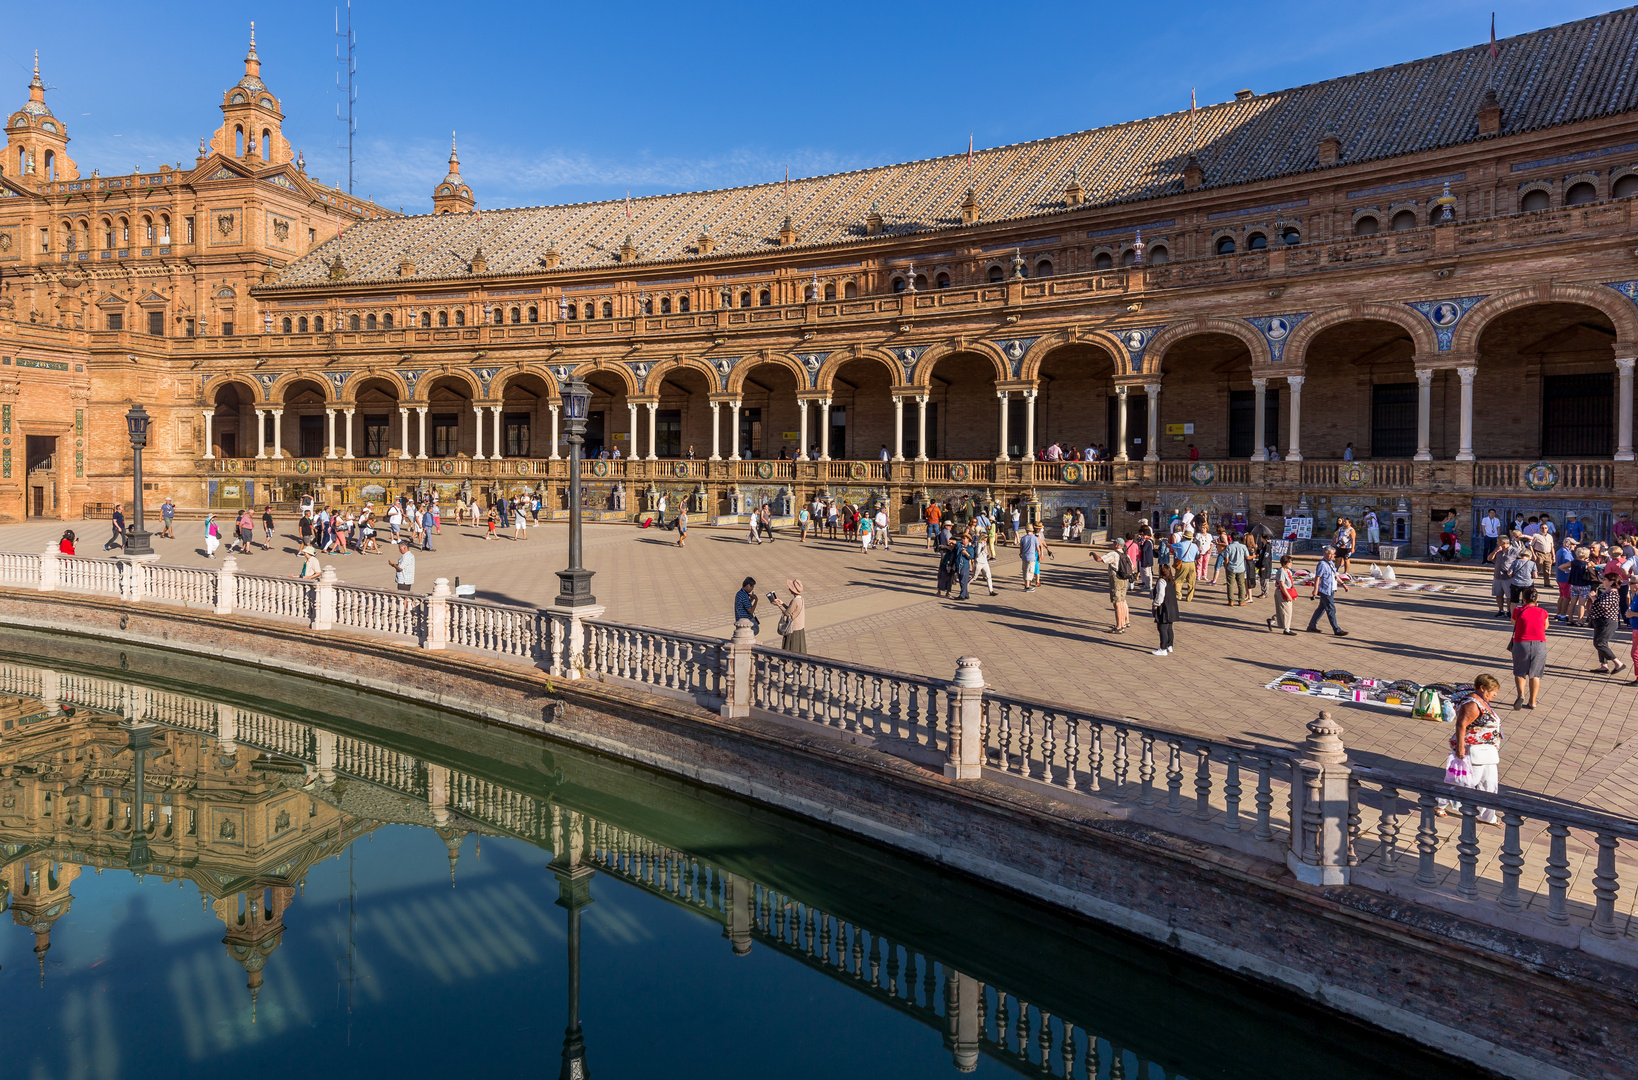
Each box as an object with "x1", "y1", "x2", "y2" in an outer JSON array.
[{"x1": 0, "y1": 631, "x2": 1477, "y2": 1080}]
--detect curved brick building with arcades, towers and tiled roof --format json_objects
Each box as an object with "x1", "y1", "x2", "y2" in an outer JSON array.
[{"x1": 9, "y1": 10, "x2": 1638, "y2": 557}]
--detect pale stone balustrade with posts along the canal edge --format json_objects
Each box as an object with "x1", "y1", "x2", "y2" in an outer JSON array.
[{"x1": 0, "y1": 551, "x2": 1638, "y2": 967}]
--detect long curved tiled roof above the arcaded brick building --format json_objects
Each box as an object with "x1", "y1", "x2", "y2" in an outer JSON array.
[{"x1": 277, "y1": 8, "x2": 1638, "y2": 285}]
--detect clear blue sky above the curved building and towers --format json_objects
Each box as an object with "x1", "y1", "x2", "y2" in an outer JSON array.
[{"x1": 0, "y1": 0, "x2": 1609, "y2": 213}]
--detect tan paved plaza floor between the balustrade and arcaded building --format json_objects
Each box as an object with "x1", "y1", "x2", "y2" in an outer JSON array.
[{"x1": 0, "y1": 521, "x2": 1638, "y2": 815}]
